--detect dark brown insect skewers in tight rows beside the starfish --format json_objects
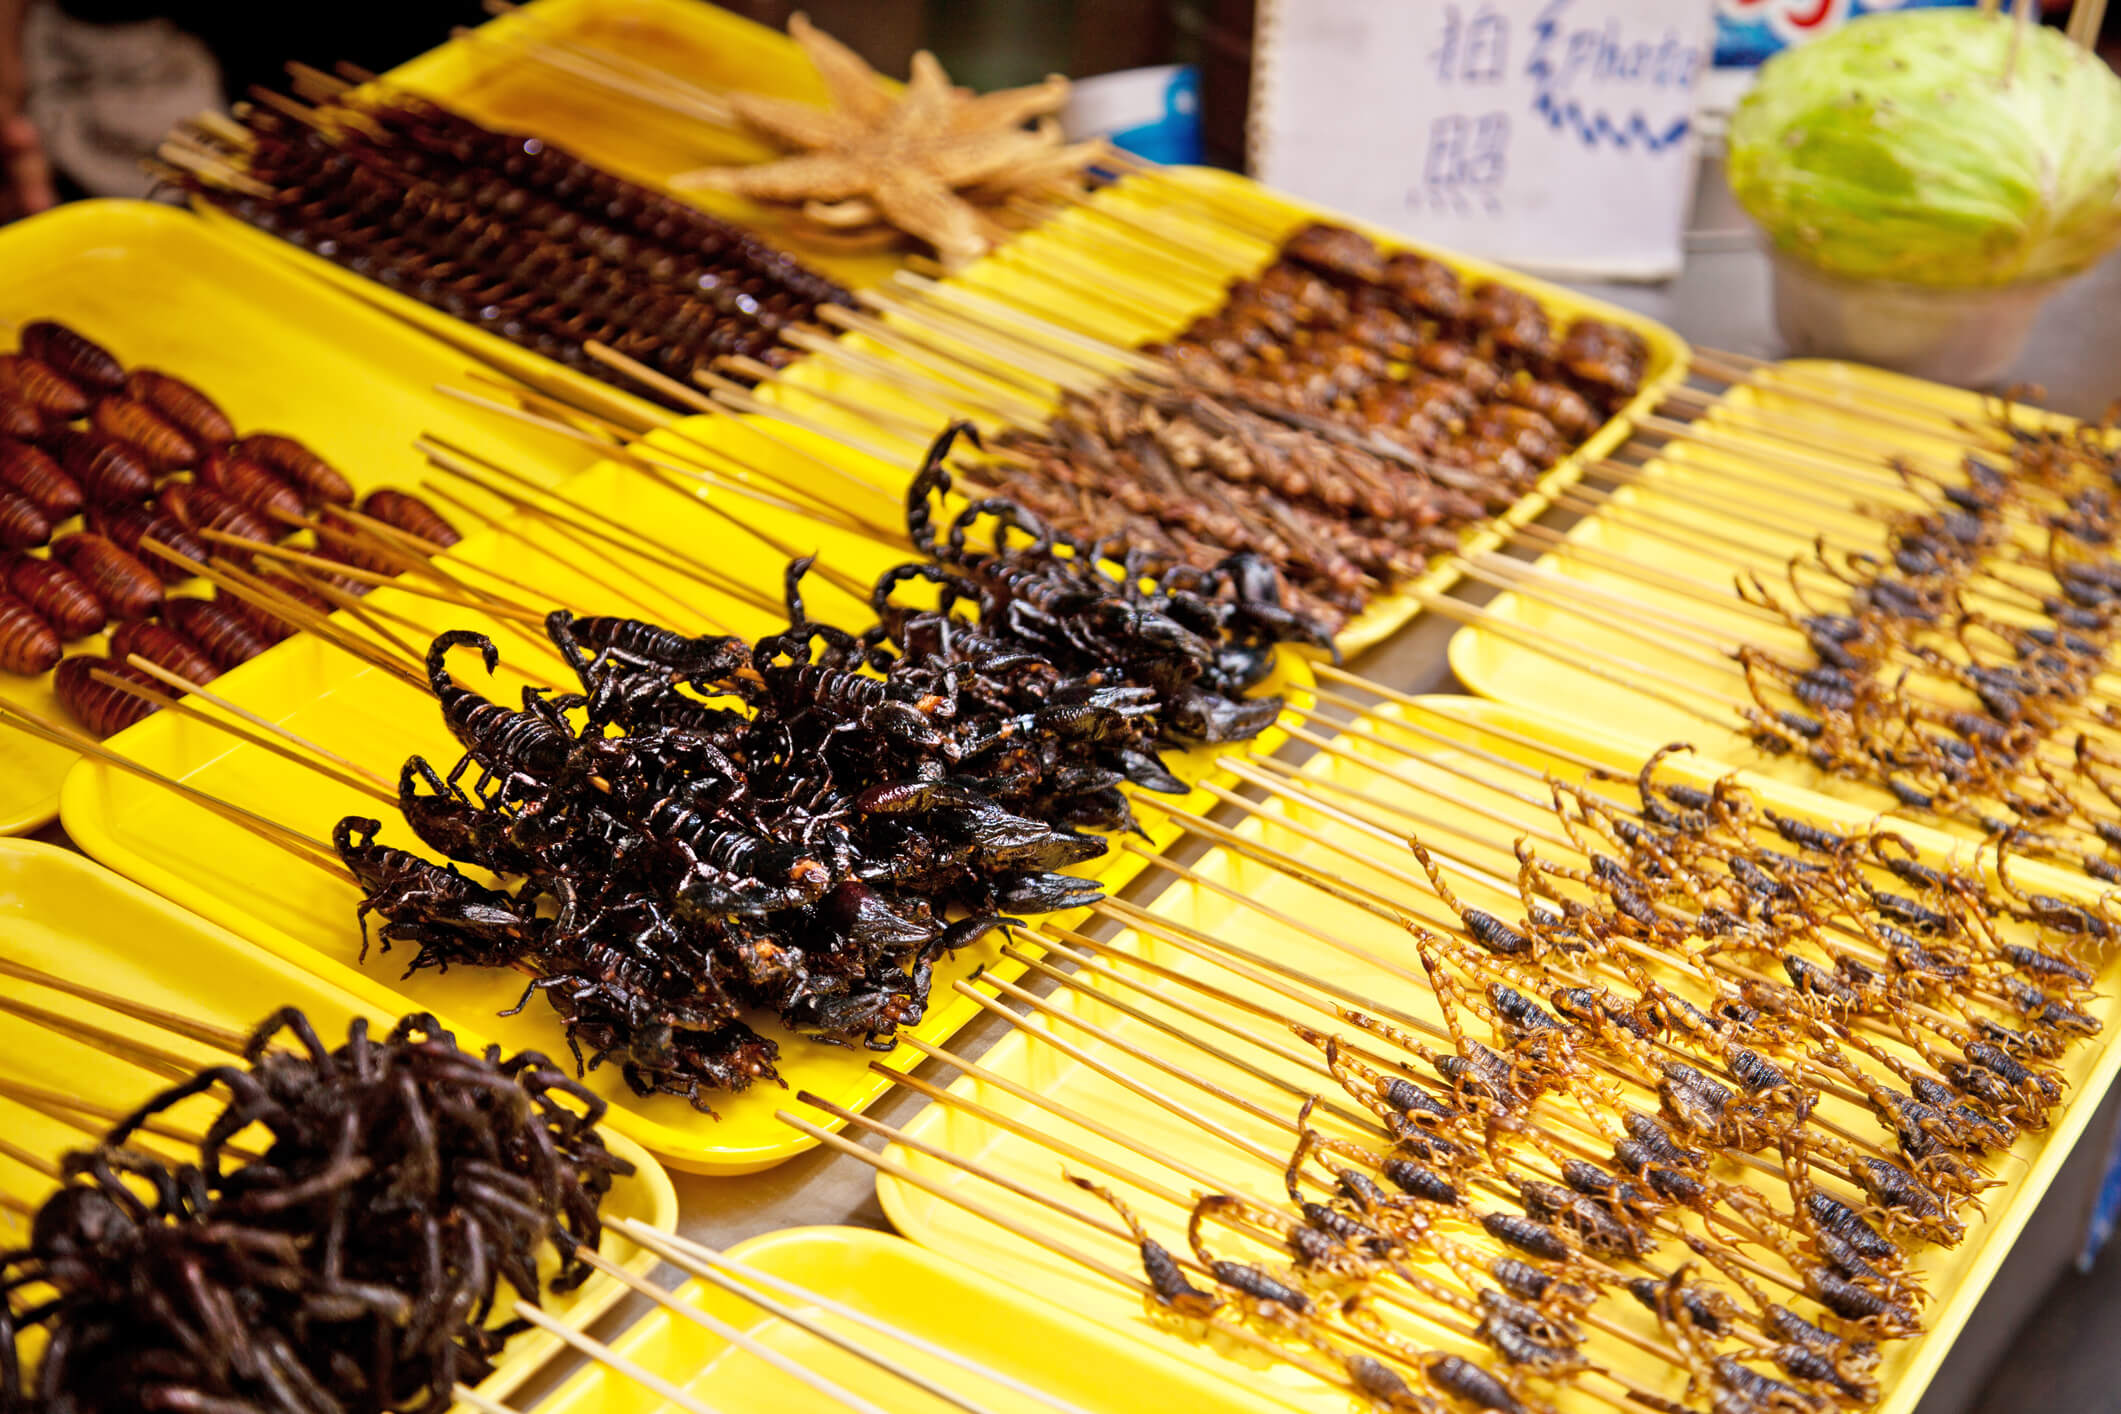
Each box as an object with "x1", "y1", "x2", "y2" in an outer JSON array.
[{"x1": 163, "y1": 85, "x2": 851, "y2": 409}]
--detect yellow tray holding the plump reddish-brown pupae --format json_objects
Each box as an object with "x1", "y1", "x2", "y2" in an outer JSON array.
[{"x1": 0, "y1": 201, "x2": 592, "y2": 833}]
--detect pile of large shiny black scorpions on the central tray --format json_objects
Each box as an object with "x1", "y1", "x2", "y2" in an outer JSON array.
[{"x1": 333, "y1": 424, "x2": 1330, "y2": 1113}]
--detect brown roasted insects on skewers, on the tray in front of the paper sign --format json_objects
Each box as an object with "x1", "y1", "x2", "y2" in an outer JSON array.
[{"x1": 984, "y1": 225, "x2": 1648, "y2": 625}]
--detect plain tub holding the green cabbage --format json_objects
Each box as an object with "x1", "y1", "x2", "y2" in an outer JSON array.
[{"x1": 1769, "y1": 248, "x2": 2068, "y2": 388}]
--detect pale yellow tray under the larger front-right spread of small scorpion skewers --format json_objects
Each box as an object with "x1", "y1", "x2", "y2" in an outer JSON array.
[{"x1": 878, "y1": 697, "x2": 2121, "y2": 1414}]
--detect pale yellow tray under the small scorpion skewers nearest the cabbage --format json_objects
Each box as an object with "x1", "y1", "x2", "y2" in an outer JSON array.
[{"x1": 1451, "y1": 360, "x2": 2104, "y2": 812}]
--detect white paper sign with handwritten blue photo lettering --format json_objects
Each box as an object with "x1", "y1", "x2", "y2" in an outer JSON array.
[{"x1": 1251, "y1": 0, "x2": 1714, "y2": 278}]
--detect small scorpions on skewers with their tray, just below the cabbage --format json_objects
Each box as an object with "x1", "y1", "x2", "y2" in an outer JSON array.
[{"x1": 1461, "y1": 364, "x2": 2121, "y2": 882}]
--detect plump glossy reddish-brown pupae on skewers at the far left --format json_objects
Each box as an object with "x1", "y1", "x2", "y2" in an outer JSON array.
[{"x1": 0, "y1": 320, "x2": 458, "y2": 736}]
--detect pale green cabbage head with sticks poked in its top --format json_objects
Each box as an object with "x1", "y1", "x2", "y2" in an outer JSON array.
[{"x1": 1731, "y1": 8, "x2": 2121, "y2": 288}]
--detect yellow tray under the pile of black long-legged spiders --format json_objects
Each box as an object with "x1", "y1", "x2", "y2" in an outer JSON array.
[{"x1": 0, "y1": 839, "x2": 677, "y2": 1399}]
